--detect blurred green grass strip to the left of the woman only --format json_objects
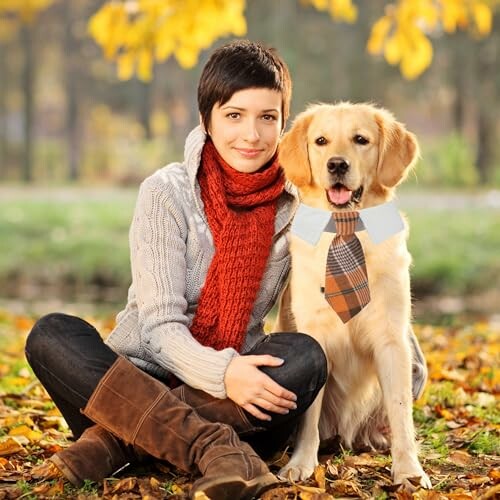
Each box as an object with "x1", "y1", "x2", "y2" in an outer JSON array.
[{"x1": 0, "y1": 191, "x2": 135, "y2": 295}]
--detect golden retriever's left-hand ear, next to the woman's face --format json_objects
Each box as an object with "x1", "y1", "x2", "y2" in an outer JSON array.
[{"x1": 278, "y1": 111, "x2": 312, "y2": 187}]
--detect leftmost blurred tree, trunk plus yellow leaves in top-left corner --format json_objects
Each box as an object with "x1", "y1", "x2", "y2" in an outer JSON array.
[{"x1": 0, "y1": 0, "x2": 53, "y2": 182}]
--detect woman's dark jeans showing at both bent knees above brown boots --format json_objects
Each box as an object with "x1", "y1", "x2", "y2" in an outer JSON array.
[{"x1": 26, "y1": 313, "x2": 327, "y2": 455}]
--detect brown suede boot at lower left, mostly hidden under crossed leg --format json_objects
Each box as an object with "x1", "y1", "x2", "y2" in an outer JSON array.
[{"x1": 32, "y1": 425, "x2": 148, "y2": 486}]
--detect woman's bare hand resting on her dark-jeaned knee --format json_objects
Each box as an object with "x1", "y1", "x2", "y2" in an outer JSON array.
[{"x1": 224, "y1": 354, "x2": 297, "y2": 420}]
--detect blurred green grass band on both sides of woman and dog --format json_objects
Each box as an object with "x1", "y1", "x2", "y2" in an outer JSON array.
[{"x1": 0, "y1": 188, "x2": 500, "y2": 300}]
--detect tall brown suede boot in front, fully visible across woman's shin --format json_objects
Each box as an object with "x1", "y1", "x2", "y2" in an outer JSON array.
[{"x1": 83, "y1": 357, "x2": 278, "y2": 500}]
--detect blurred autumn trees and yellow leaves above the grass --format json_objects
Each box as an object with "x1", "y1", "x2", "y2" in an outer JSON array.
[{"x1": 0, "y1": 0, "x2": 500, "y2": 186}]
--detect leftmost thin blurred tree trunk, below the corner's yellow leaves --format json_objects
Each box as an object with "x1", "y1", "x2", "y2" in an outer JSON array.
[{"x1": 21, "y1": 26, "x2": 35, "y2": 182}]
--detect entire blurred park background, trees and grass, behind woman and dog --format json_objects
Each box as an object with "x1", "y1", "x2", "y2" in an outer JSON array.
[{"x1": 0, "y1": 0, "x2": 500, "y2": 314}]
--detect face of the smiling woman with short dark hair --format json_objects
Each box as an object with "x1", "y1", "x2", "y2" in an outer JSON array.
[{"x1": 208, "y1": 88, "x2": 283, "y2": 173}]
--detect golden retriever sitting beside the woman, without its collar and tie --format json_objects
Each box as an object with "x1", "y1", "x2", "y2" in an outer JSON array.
[{"x1": 274, "y1": 103, "x2": 431, "y2": 488}]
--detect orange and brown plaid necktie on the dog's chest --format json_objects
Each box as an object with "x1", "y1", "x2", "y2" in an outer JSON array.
[{"x1": 325, "y1": 212, "x2": 370, "y2": 323}]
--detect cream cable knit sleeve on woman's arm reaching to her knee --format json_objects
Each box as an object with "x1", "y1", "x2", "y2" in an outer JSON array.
[{"x1": 130, "y1": 176, "x2": 237, "y2": 398}]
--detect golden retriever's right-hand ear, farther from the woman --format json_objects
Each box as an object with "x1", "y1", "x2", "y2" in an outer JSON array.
[{"x1": 375, "y1": 110, "x2": 420, "y2": 187}]
